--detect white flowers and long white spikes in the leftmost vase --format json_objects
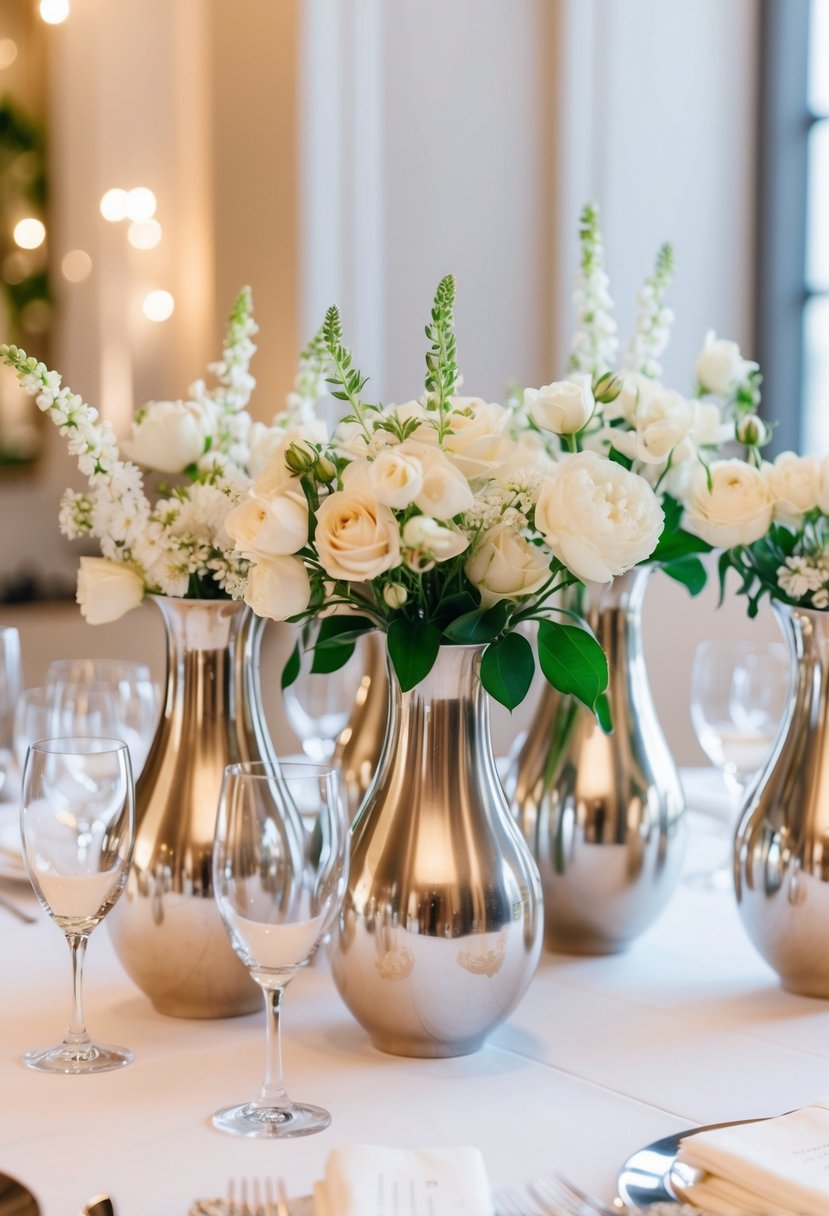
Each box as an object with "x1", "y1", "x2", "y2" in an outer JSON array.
[{"x1": 0, "y1": 288, "x2": 326, "y2": 624}]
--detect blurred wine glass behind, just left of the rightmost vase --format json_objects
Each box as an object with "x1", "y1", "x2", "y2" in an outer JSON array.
[{"x1": 690, "y1": 642, "x2": 790, "y2": 885}]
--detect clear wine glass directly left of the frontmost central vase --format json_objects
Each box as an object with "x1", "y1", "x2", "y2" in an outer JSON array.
[{"x1": 213, "y1": 762, "x2": 349, "y2": 1138}]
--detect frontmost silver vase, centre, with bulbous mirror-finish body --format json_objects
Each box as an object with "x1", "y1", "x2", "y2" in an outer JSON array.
[{"x1": 332, "y1": 646, "x2": 542, "y2": 1057}]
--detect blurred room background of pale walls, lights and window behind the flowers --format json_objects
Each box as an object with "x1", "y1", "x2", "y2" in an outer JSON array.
[{"x1": 0, "y1": 0, "x2": 829, "y2": 762}]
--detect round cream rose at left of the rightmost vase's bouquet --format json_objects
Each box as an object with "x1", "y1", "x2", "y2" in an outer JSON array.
[{"x1": 684, "y1": 460, "x2": 774, "y2": 548}]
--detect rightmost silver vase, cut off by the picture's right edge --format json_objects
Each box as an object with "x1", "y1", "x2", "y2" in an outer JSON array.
[{"x1": 734, "y1": 603, "x2": 829, "y2": 997}]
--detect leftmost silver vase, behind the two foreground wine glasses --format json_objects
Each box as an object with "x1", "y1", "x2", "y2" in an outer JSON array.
[{"x1": 107, "y1": 596, "x2": 266, "y2": 1018}]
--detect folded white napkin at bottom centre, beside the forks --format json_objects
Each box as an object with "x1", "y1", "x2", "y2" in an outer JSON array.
[{"x1": 314, "y1": 1144, "x2": 492, "y2": 1216}]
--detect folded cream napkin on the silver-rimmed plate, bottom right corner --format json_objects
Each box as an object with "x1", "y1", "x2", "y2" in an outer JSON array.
[{"x1": 677, "y1": 1098, "x2": 829, "y2": 1216}]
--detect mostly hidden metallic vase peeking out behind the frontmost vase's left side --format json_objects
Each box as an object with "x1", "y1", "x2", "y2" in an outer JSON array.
[{"x1": 334, "y1": 631, "x2": 389, "y2": 816}]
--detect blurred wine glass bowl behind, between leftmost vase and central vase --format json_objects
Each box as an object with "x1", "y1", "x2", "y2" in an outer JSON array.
[{"x1": 283, "y1": 626, "x2": 365, "y2": 762}]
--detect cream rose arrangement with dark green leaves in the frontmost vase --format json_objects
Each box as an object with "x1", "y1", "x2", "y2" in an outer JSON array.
[{"x1": 232, "y1": 276, "x2": 664, "y2": 726}]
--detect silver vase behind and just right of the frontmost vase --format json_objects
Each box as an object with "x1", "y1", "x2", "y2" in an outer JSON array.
[{"x1": 512, "y1": 569, "x2": 686, "y2": 955}]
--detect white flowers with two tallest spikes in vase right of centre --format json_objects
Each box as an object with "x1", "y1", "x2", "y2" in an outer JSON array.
[{"x1": 524, "y1": 204, "x2": 769, "y2": 595}]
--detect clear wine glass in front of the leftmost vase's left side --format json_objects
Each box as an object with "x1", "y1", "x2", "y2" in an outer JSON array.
[{"x1": 21, "y1": 738, "x2": 135, "y2": 1073}]
